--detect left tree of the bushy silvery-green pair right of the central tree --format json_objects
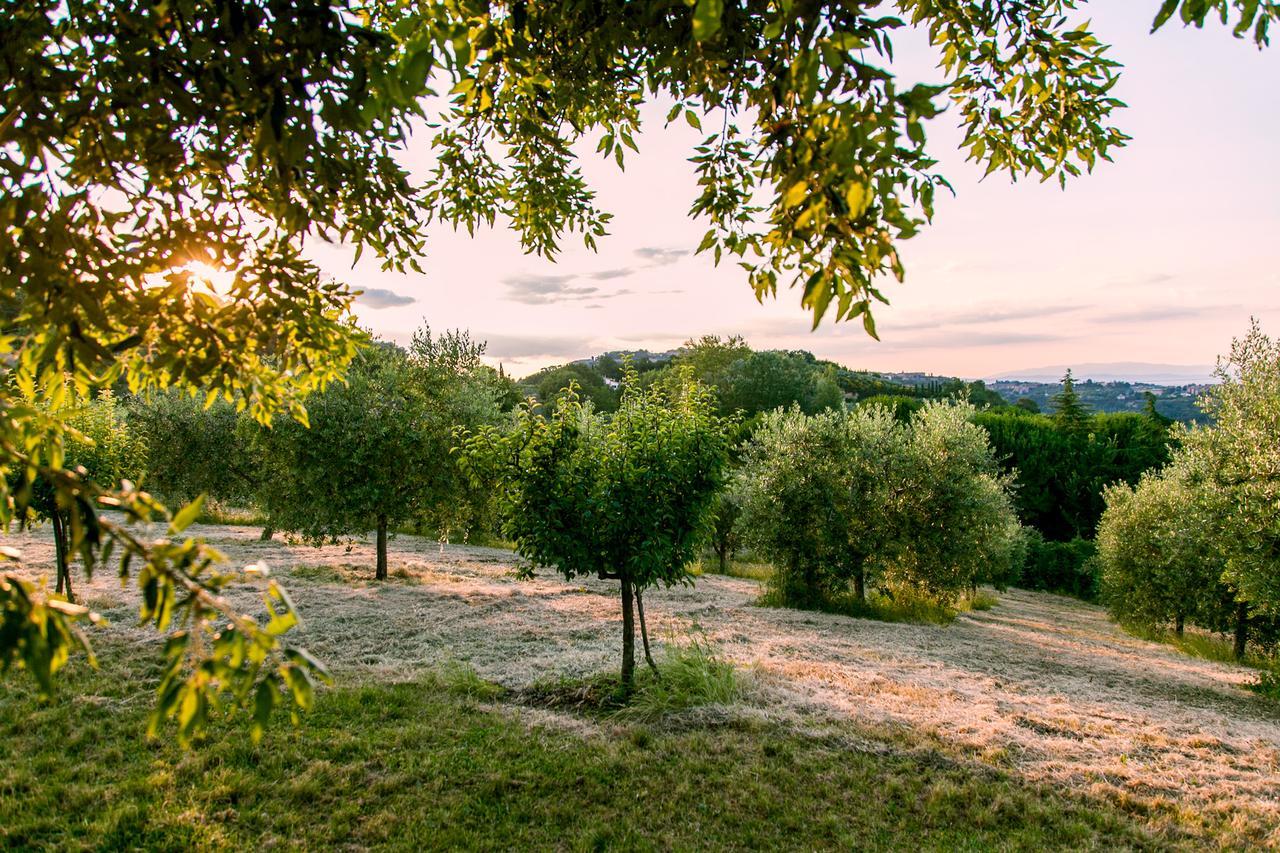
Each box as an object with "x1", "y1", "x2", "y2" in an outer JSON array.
[{"x1": 739, "y1": 406, "x2": 905, "y2": 608}]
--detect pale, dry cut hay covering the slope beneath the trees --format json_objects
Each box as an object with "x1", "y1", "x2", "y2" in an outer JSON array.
[{"x1": 10, "y1": 517, "x2": 1280, "y2": 845}]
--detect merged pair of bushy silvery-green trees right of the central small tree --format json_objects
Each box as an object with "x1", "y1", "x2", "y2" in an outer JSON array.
[{"x1": 737, "y1": 402, "x2": 1023, "y2": 610}]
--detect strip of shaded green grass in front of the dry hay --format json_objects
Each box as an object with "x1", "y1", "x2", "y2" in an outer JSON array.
[{"x1": 0, "y1": 640, "x2": 1187, "y2": 850}]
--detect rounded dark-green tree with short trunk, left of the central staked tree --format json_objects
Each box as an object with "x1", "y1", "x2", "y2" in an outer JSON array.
[{"x1": 259, "y1": 329, "x2": 498, "y2": 580}]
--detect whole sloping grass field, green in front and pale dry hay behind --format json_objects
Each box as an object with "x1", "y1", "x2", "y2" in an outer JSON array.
[{"x1": 0, "y1": 528, "x2": 1280, "y2": 849}]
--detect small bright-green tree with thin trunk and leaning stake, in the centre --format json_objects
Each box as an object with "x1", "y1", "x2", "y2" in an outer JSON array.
[{"x1": 463, "y1": 370, "x2": 728, "y2": 692}]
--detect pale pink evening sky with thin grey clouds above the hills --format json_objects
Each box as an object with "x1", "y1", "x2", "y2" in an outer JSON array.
[{"x1": 311, "y1": 0, "x2": 1280, "y2": 378}]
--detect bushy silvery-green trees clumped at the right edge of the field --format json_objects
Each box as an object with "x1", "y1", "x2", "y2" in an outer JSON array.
[{"x1": 1098, "y1": 323, "x2": 1280, "y2": 660}]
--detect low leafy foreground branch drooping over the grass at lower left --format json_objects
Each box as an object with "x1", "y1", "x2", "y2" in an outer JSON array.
[{"x1": 0, "y1": 411, "x2": 329, "y2": 743}]
